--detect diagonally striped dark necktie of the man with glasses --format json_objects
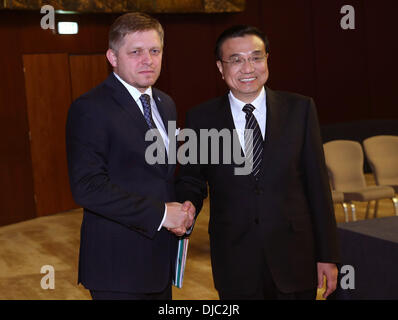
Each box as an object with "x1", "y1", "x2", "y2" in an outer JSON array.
[{"x1": 242, "y1": 104, "x2": 263, "y2": 176}]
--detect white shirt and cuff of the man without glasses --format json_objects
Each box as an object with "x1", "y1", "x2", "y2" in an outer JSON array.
[{"x1": 113, "y1": 72, "x2": 169, "y2": 231}]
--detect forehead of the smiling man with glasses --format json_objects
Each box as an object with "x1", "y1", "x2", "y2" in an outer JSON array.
[{"x1": 221, "y1": 35, "x2": 265, "y2": 56}]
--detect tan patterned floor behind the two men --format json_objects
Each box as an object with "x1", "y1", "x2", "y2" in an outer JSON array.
[{"x1": 0, "y1": 175, "x2": 394, "y2": 300}]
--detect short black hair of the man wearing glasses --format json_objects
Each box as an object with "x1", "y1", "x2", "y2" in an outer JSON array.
[{"x1": 215, "y1": 25, "x2": 269, "y2": 60}]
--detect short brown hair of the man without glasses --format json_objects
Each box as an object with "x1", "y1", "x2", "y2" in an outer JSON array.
[{"x1": 109, "y1": 12, "x2": 164, "y2": 51}]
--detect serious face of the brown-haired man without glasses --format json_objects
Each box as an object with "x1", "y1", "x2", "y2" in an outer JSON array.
[{"x1": 106, "y1": 30, "x2": 163, "y2": 92}]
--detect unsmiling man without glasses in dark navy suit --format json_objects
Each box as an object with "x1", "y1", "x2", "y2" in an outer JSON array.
[{"x1": 66, "y1": 13, "x2": 194, "y2": 300}]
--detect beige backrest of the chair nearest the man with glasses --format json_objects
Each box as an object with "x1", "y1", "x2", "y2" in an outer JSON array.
[{"x1": 323, "y1": 140, "x2": 366, "y2": 192}]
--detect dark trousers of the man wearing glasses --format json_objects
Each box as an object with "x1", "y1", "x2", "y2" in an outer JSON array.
[{"x1": 218, "y1": 261, "x2": 317, "y2": 300}]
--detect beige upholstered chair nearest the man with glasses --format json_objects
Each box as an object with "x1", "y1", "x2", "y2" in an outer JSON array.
[{"x1": 323, "y1": 140, "x2": 397, "y2": 221}]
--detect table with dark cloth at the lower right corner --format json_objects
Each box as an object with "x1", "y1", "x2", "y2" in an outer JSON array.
[{"x1": 330, "y1": 216, "x2": 398, "y2": 300}]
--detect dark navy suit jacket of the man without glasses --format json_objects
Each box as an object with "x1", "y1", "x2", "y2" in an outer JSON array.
[{"x1": 66, "y1": 74, "x2": 177, "y2": 293}]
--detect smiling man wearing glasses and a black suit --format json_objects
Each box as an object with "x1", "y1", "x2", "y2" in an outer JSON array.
[{"x1": 177, "y1": 26, "x2": 338, "y2": 299}]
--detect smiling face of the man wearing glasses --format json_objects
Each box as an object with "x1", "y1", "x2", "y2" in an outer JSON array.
[{"x1": 217, "y1": 35, "x2": 268, "y2": 103}]
